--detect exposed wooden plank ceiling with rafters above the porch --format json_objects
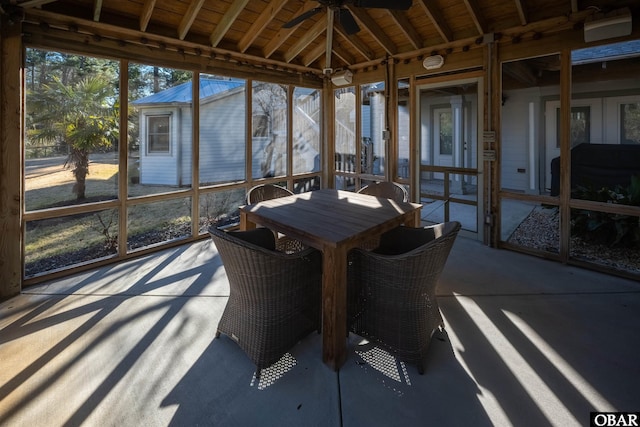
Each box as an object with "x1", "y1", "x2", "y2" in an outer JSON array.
[{"x1": 6, "y1": 0, "x2": 640, "y2": 75}]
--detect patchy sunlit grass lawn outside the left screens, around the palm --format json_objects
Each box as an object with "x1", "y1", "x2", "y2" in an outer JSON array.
[{"x1": 25, "y1": 158, "x2": 191, "y2": 276}]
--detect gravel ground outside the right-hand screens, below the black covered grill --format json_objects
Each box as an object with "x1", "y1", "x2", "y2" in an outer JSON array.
[{"x1": 508, "y1": 207, "x2": 640, "y2": 274}]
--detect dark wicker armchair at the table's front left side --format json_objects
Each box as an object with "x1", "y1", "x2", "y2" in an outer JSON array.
[{"x1": 209, "y1": 227, "x2": 322, "y2": 377}]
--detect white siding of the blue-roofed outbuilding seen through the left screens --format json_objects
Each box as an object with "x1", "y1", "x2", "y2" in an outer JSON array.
[{"x1": 140, "y1": 85, "x2": 319, "y2": 186}]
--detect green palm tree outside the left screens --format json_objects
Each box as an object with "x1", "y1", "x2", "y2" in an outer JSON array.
[{"x1": 28, "y1": 76, "x2": 119, "y2": 200}]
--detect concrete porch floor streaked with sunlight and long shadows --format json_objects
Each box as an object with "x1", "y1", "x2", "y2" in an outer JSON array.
[{"x1": 0, "y1": 237, "x2": 640, "y2": 427}]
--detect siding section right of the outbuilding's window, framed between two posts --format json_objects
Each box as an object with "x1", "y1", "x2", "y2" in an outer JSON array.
[{"x1": 200, "y1": 87, "x2": 246, "y2": 183}]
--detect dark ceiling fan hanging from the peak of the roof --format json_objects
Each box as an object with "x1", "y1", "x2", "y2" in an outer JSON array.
[{"x1": 282, "y1": 0, "x2": 412, "y2": 74}]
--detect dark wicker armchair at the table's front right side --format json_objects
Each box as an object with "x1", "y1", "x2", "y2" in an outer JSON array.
[{"x1": 347, "y1": 221, "x2": 460, "y2": 374}]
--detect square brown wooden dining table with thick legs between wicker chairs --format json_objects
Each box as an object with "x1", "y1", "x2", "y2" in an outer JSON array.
[{"x1": 240, "y1": 189, "x2": 422, "y2": 371}]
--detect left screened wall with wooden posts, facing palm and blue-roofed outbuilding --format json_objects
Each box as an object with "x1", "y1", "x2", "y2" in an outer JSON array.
[{"x1": 23, "y1": 49, "x2": 323, "y2": 280}]
